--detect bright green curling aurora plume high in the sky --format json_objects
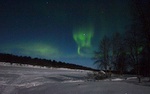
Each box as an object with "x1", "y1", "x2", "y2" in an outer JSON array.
[{"x1": 73, "y1": 26, "x2": 94, "y2": 56}]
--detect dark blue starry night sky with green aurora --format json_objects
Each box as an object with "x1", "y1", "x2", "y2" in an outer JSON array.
[{"x1": 0, "y1": 0, "x2": 131, "y2": 67}]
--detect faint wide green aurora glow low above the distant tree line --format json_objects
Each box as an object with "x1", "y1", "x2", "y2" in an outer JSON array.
[{"x1": 3, "y1": 42, "x2": 60, "y2": 58}]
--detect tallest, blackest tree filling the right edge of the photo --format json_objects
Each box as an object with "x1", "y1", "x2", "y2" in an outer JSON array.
[{"x1": 132, "y1": 0, "x2": 150, "y2": 80}]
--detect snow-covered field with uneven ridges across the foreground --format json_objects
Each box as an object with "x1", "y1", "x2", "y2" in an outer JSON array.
[{"x1": 0, "y1": 64, "x2": 150, "y2": 94}]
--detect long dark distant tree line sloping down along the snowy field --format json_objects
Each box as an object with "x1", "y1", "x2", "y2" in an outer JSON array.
[{"x1": 0, "y1": 53, "x2": 94, "y2": 70}]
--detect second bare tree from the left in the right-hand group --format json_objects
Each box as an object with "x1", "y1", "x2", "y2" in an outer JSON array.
[{"x1": 111, "y1": 32, "x2": 127, "y2": 74}]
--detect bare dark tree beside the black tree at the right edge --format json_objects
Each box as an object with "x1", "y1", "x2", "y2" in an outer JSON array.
[{"x1": 125, "y1": 25, "x2": 144, "y2": 82}]
